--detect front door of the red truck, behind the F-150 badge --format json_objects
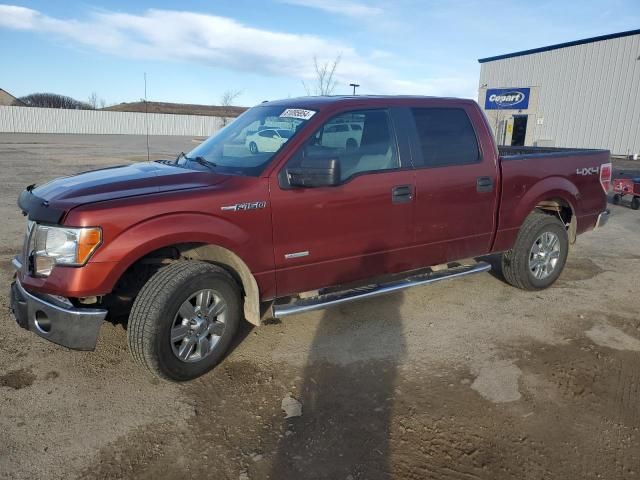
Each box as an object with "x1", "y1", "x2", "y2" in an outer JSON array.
[{"x1": 271, "y1": 110, "x2": 415, "y2": 296}]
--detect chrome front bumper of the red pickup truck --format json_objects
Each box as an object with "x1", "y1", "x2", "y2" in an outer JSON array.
[{"x1": 11, "y1": 278, "x2": 107, "y2": 350}]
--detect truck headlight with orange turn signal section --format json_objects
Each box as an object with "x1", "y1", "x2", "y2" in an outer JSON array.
[{"x1": 29, "y1": 225, "x2": 102, "y2": 277}]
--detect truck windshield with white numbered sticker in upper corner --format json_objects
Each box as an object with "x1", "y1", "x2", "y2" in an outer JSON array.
[{"x1": 177, "y1": 106, "x2": 316, "y2": 176}]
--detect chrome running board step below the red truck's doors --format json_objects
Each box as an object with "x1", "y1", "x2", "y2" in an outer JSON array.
[{"x1": 272, "y1": 262, "x2": 491, "y2": 318}]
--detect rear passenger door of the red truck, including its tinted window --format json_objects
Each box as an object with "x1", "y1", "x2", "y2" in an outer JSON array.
[{"x1": 408, "y1": 104, "x2": 499, "y2": 265}]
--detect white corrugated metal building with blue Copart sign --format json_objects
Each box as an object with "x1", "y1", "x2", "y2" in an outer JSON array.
[{"x1": 478, "y1": 30, "x2": 640, "y2": 155}]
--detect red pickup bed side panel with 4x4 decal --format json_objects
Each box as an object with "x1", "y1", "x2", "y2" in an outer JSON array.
[{"x1": 493, "y1": 150, "x2": 610, "y2": 252}]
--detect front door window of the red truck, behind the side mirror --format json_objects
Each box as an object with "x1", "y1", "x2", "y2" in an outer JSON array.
[{"x1": 292, "y1": 110, "x2": 400, "y2": 181}]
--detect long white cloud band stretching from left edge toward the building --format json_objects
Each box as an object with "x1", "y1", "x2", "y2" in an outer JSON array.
[{"x1": 0, "y1": 4, "x2": 475, "y2": 95}]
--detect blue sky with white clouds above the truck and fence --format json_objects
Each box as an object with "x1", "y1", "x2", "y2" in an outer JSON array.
[{"x1": 0, "y1": 0, "x2": 640, "y2": 106}]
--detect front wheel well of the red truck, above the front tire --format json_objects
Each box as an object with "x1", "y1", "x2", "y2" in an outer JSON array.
[{"x1": 113, "y1": 243, "x2": 261, "y2": 325}]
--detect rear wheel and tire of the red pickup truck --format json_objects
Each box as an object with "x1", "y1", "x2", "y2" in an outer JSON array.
[{"x1": 502, "y1": 211, "x2": 569, "y2": 290}]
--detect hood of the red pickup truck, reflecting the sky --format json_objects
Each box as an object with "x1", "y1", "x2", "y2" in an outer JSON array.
[{"x1": 18, "y1": 162, "x2": 229, "y2": 223}]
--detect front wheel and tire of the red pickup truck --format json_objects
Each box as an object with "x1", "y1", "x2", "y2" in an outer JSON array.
[{"x1": 127, "y1": 261, "x2": 242, "y2": 382}]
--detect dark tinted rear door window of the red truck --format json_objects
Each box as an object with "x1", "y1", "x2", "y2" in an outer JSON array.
[{"x1": 412, "y1": 108, "x2": 480, "y2": 167}]
